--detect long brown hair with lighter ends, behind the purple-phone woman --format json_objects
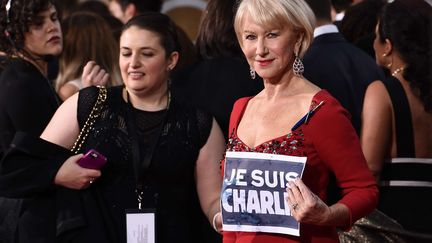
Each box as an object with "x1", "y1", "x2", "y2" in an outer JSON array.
[{"x1": 55, "y1": 12, "x2": 122, "y2": 92}]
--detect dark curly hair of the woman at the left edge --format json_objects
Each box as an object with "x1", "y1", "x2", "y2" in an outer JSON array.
[{"x1": 0, "y1": 0, "x2": 52, "y2": 56}]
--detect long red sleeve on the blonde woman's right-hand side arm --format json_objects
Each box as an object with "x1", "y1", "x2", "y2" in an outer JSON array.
[{"x1": 304, "y1": 92, "x2": 378, "y2": 227}]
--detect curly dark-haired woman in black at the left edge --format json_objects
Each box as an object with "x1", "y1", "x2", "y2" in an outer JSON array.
[{"x1": 0, "y1": 0, "x2": 62, "y2": 242}]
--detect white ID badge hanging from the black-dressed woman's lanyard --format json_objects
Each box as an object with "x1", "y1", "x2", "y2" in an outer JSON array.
[{"x1": 126, "y1": 208, "x2": 156, "y2": 243}]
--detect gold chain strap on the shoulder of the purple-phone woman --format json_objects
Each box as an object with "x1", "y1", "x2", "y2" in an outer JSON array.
[{"x1": 71, "y1": 86, "x2": 107, "y2": 154}]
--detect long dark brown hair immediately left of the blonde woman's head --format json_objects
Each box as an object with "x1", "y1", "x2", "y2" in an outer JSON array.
[{"x1": 195, "y1": 0, "x2": 242, "y2": 59}]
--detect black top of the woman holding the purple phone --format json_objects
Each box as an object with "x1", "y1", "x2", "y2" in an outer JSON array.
[{"x1": 78, "y1": 87, "x2": 212, "y2": 242}]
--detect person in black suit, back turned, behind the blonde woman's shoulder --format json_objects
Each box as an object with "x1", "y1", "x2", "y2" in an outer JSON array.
[{"x1": 303, "y1": 0, "x2": 384, "y2": 135}]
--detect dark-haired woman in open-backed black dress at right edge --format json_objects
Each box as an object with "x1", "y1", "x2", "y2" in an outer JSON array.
[{"x1": 362, "y1": 0, "x2": 432, "y2": 239}]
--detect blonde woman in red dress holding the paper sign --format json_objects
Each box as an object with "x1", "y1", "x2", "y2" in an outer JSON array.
[{"x1": 216, "y1": 0, "x2": 378, "y2": 243}]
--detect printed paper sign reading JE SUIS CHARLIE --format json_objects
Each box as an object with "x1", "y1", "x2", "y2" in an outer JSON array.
[{"x1": 221, "y1": 152, "x2": 307, "y2": 236}]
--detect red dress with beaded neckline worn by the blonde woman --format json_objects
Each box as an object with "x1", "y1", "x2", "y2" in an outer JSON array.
[{"x1": 222, "y1": 90, "x2": 378, "y2": 243}]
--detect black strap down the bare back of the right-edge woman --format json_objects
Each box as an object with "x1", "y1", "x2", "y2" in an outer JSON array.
[{"x1": 384, "y1": 77, "x2": 415, "y2": 158}]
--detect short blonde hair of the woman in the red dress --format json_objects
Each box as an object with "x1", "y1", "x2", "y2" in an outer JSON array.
[{"x1": 234, "y1": 0, "x2": 315, "y2": 57}]
